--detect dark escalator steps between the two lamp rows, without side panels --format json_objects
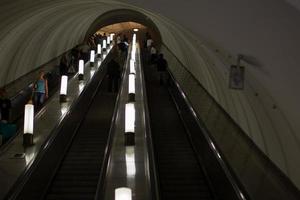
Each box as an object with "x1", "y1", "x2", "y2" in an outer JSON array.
[{"x1": 45, "y1": 77, "x2": 117, "y2": 200}]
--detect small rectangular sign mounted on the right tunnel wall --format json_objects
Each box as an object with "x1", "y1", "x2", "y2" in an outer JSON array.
[{"x1": 229, "y1": 65, "x2": 245, "y2": 90}]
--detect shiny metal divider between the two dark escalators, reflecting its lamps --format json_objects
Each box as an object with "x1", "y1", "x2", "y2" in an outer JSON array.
[{"x1": 104, "y1": 43, "x2": 151, "y2": 200}]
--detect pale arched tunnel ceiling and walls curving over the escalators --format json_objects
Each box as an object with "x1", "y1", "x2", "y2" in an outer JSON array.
[{"x1": 0, "y1": 0, "x2": 300, "y2": 191}]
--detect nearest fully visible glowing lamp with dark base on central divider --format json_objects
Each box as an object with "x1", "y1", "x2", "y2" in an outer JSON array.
[{"x1": 125, "y1": 103, "x2": 135, "y2": 146}]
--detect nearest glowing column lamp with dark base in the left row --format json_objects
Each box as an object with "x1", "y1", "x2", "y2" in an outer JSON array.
[{"x1": 23, "y1": 103, "x2": 34, "y2": 146}]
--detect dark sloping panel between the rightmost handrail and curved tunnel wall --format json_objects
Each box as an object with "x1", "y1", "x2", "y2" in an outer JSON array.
[{"x1": 161, "y1": 46, "x2": 298, "y2": 199}]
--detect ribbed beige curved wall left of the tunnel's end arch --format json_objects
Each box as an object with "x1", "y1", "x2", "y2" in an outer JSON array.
[{"x1": 0, "y1": 0, "x2": 123, "y2": 85}]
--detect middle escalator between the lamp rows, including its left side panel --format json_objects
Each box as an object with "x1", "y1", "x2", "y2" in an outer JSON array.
[{"x1": 5, "y1": 53, "x2": 122, "y2": 200}]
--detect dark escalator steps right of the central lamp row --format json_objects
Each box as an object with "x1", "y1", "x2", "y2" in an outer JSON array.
[{"x1": 144, "y1": 61, "x2": 216, "y2": 200}]
